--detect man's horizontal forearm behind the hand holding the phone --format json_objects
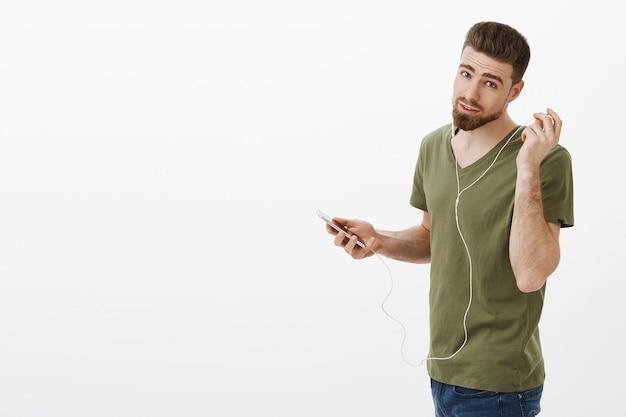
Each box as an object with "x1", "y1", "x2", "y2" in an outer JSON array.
[{"x1": 376, "y1": 224, "x2": 430, "y2": 263}]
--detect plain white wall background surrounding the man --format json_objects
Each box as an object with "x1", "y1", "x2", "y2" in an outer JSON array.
[{"x1": 0, "y1": 0, "x2": 626, "y2": 417}]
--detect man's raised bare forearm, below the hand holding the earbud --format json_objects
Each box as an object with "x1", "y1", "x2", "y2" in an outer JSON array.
[{"x1": 509, "y1": 169, "x2": 560, "y2": 292}]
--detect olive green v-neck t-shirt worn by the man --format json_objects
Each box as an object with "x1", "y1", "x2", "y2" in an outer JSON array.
[{"x1": 410, "y1": 125, "x2": 574, "y2": 392}]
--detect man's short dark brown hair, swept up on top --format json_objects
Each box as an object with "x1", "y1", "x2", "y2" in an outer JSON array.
[{"x1": 463, "y1": 22, "x2": 530, "y2": 84}]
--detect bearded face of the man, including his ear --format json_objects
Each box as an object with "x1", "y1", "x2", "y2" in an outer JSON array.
[{"x1": 452, "y1": 47, "x2": 521, "y2": 131}]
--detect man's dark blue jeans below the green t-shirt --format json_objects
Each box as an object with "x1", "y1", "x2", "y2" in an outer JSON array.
[{"x1": 430, "y1": 379, "x2": 543, "y2": 417}]
